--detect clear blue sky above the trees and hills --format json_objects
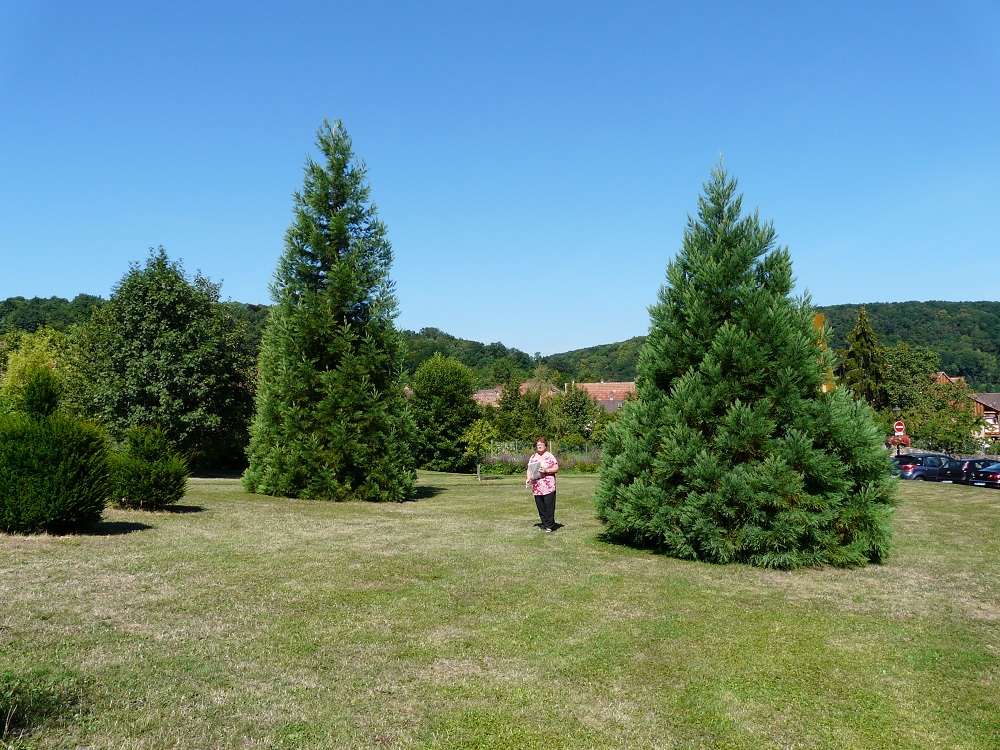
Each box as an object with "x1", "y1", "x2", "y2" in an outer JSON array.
[{"x1": 0, "y1": 0, "x2": 1000, "y2": 354}]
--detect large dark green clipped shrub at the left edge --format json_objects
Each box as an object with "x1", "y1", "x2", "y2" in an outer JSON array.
[{"x1": 0, "y1": 413, "x2": 108, "y2": 534}]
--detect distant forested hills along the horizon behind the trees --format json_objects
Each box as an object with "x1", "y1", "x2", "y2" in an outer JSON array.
[{"x1": 0, "y1": 294, "x2": 1000, "y2": 391}]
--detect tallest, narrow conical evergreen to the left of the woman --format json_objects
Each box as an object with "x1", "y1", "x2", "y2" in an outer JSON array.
[{"x1": 243, "y1": 121, "x2": 415, "y2": 501}]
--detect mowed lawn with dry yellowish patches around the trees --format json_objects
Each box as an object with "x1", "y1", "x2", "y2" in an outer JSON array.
[{"x1": 0, "y1": 473, "x2": 1000, "y2": 750}]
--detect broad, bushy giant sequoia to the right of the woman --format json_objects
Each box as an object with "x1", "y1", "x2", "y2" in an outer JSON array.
[{"x1": 595, "y1": 167, "x2": 896, "y2": 568}]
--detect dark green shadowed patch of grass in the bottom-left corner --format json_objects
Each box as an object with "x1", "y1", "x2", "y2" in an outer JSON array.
[{"x1": 0, "y1": 669, "x2": 84, "y2": 747}]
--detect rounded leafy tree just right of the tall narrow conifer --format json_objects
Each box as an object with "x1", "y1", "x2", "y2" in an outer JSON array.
[{"x1": 410, "y1": 352, "x2": 479, "y2": 471}]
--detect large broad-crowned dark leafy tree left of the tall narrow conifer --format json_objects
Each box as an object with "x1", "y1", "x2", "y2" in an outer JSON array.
[{"x1": 67, "y1": 247, "x2": 252, "y2": 466}]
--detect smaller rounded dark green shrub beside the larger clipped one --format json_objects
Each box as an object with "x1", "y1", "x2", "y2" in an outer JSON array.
[{"x1": 110, "y1": 427, "x2": 188, "y2": 510}]
